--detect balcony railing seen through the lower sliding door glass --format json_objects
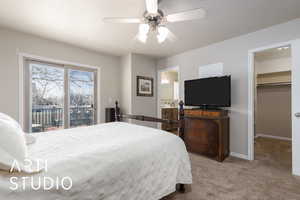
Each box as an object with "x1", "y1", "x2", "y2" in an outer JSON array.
[{"x1": 31, "y1": 106, "x2": 94, "y2": 132}]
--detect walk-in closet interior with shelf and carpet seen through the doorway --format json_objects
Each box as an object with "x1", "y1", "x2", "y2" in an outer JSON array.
[{"x1": 254, "y1": 45, "x2": 292, "y2": 171}]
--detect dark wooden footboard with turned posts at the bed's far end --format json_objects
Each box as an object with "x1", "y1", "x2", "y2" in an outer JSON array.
[{"x1": 115, "y1": 101, "x2": 184, "y2": 139}]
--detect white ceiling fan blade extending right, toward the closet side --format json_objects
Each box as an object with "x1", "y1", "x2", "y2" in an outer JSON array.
[{"x1": 166, "y1": 8, "x2": 206, "y2": 22}]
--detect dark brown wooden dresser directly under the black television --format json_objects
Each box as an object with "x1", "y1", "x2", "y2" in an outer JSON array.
[{"x1": 184, "y1": 109, "x2": 229, "y2": 162}]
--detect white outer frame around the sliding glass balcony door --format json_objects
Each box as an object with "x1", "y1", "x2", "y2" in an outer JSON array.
[{"x1": 17, "y1": 52, "x2": 101, "y2": 128}]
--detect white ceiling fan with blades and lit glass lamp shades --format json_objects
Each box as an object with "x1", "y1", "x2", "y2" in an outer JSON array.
[{"x1": 103, "y1": 0, "x2": 206, "y2": 43}]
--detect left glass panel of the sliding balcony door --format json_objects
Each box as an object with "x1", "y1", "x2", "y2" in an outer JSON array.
[{"x1": 29, "y1": 62, "x2": 64, "y2": 132}]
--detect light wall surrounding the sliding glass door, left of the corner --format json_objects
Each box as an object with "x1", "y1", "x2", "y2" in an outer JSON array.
[{"x1": 0, "y1": 29, "x2": 120, "y2": 125}]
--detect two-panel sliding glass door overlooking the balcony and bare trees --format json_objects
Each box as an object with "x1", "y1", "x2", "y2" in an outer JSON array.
[{"x1": 25, "y1": 61, "x2": 97, "y2": 132}]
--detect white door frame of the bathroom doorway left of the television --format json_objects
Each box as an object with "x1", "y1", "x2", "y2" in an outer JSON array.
[{"x1": 156, "y1": 66, "x2": 181, "y2": 128}]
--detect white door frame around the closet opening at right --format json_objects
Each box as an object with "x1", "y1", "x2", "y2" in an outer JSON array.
[{"x1": 248, "y1": 40, "x2": 294, "y2": 172}]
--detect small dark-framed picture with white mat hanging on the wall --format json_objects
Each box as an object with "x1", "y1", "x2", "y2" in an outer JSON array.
[{"x1": 136, "y1": 76, "x2": 153, "y2": 97}]
